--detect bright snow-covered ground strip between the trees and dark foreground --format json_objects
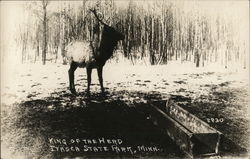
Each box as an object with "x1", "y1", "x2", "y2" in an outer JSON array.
[{"x1": 1, "y1": 63, "x2": 249, "y2": 104}]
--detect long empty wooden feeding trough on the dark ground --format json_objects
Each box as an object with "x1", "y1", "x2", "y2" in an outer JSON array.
[{"x1": 149, "y1": 102, "x2": 222, "y2": 157}]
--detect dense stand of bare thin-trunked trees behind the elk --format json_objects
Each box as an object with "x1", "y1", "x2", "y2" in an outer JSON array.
[{"x1": 16, "y1": 0, "x2": 249, "y2": 68}]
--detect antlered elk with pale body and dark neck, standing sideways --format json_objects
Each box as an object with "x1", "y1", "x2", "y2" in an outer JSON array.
[{"x1": 66, "y1": 9, "x2": 124, "y2": 94}]
